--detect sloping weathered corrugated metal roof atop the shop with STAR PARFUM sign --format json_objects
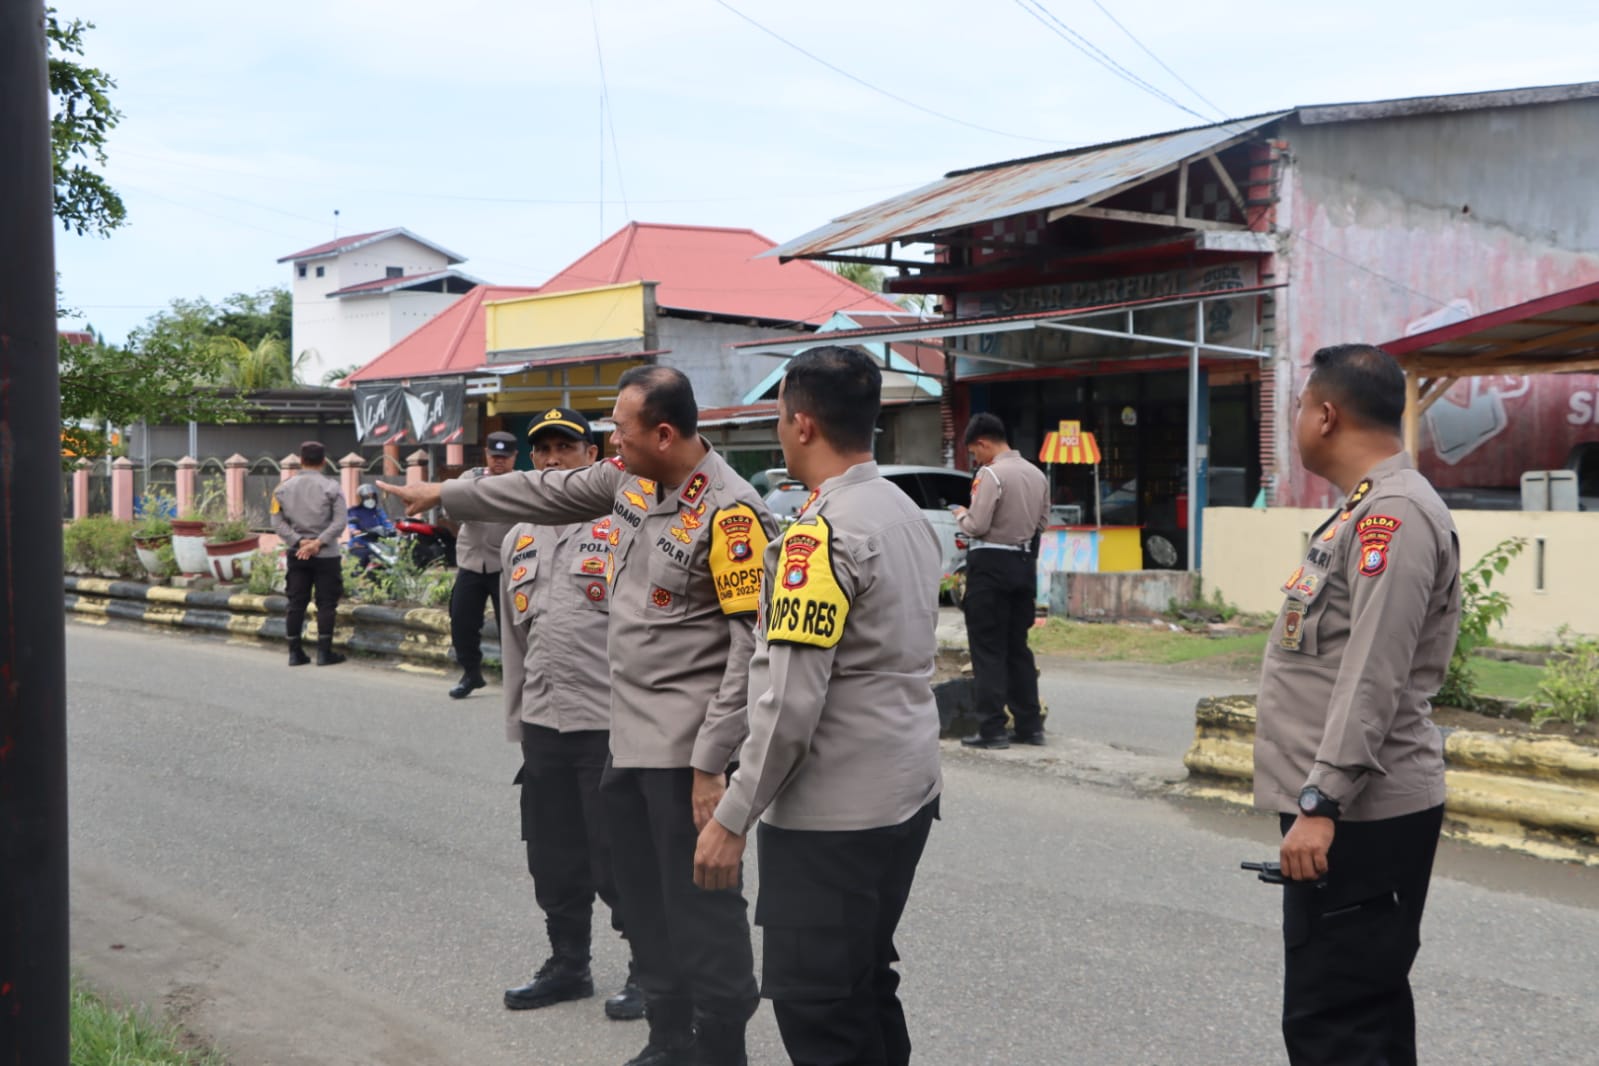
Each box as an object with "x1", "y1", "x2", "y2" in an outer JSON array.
[{"x1": 766, "y1": 112, "x2": 1292, "y2": 259}]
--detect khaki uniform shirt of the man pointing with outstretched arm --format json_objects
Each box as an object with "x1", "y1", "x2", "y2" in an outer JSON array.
[{"x1": 441, "y1": 444, "x2": 776, "y2": 774}]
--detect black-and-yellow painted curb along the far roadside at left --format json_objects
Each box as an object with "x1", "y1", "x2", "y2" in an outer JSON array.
[{"x1": 66, "y1": 574, "x2": 500, "y2": 668}]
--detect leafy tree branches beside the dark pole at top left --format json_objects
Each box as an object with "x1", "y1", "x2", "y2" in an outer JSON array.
[{"x1": 45, "y1": 8, "x2": 128, "y2": 237}]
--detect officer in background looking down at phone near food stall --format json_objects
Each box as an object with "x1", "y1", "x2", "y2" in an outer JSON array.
[{"x1": 955, "y1": 414, "x2": 1049, "y2": 748}]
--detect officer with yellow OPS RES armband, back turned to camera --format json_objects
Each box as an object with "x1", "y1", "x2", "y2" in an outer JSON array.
[{"x1": 694, "y1": 347, "x2": 942, "y2": 1066}]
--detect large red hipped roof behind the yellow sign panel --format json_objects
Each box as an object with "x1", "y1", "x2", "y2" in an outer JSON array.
[{"x1": 539, "y1": 222, "x2": 902, "y2": 326}]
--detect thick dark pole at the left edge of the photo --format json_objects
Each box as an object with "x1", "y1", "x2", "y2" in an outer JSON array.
[{"x1": 0, "y1": 0, "x2": 69, "y2": 1066}]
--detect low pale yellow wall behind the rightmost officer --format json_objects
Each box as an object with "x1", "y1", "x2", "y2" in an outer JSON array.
[{"x1": 1201, "y1": 507, "x2": 1599, "y2": 644}]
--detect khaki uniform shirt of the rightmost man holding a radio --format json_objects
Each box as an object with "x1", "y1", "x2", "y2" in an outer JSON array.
[{"x1": 1255, "y1": 454, "x2": 1460, "y2": 821}]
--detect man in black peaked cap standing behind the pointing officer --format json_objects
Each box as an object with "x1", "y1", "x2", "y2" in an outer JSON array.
[{"x1": 502, "y1": 408, "x2": 644, "y2": 1021}]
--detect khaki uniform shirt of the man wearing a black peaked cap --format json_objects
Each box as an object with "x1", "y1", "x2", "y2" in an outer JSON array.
[{"x1": 497, "y1": 523, "x2": 611, "y2": 743}]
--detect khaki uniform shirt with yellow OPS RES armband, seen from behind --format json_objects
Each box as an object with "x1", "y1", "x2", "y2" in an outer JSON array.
[{"x1": 716, "y1": 462, "x2": 943, "y2": 836}]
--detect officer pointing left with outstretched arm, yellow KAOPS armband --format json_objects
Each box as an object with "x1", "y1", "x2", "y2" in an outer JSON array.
[{"x1": 379, "y1": 366, "x2": 776, "y2": 1066}]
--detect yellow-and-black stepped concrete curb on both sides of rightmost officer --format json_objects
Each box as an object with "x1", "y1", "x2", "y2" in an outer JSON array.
[{"x1": 1183, "y1": 695, "x2": 1599, "y2": 866}]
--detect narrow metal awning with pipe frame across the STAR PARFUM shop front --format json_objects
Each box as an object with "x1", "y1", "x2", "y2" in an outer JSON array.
[{"x1": 728, "y1": 283, "x2": 1287, "y2": 363}]
